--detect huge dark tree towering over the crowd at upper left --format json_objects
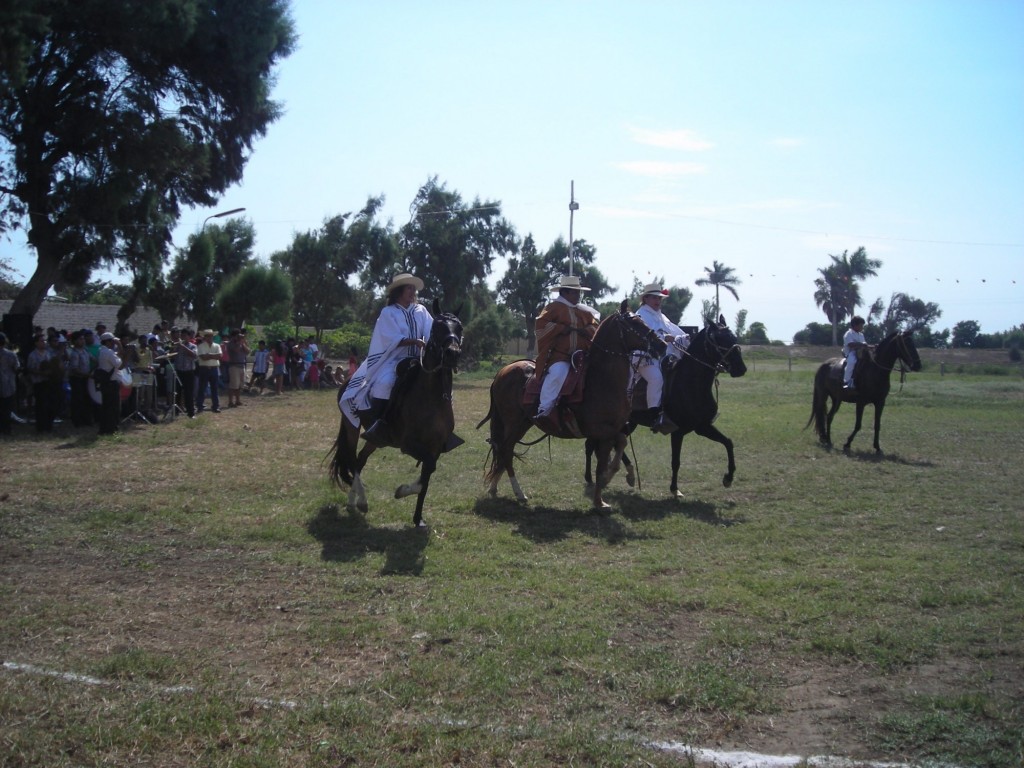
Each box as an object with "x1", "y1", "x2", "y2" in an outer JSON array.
[{"x1": 0, "y1": 0, "x2": 295, "y2": 314}]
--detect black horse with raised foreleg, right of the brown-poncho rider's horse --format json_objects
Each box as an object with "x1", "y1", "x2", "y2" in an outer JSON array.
[{"x1": 584, "y1": 316, "x2": 746, "y2": 496}]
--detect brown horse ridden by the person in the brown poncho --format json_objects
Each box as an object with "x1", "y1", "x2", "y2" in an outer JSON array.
[{"x1": 476, "y1": 301, "x2": 665, "y2": 508}]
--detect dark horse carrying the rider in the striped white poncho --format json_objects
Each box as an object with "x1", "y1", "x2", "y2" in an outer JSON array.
[{"x1": 328, "y1": 300, "x2": 463, "y2": 528}]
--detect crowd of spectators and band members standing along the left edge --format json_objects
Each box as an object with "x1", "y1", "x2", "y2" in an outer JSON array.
[{"x1": 0, "y1": 322, "x2": 351, "y2": 435}]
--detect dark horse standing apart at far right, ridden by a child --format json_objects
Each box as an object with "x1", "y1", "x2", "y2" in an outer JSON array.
[{"x1": 804, "y1": 331, "x2": 921, "y2": 454}]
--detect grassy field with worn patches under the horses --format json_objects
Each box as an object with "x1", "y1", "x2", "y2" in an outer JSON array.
[{"x1": 0, "y1": 358, "x2": 1024, "y2": 766}]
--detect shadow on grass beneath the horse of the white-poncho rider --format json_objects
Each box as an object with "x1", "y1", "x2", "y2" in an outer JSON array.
[{"x1": 306, "y1": 504, "x2": 430, "y2": 575}]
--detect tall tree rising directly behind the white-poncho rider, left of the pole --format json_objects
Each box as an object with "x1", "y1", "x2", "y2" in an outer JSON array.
[{"x1": 387, "y1": 176, "x2": 519, "y2": 309}]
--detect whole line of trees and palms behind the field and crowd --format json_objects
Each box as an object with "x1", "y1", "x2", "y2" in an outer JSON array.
[{"x1": 0, "y1": 0, "x2": 1015, "y2": 358}]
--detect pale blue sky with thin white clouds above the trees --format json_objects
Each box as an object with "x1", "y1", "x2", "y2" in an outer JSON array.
[{"x1": 8, "y1": 0, "x2": 1024, "y2": 340}]
